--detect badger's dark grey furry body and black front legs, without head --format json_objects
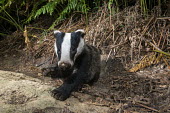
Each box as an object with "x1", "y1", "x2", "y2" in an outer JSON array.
[{"x1": 42, "y1": 30, "x2": 101, "y2": 101}]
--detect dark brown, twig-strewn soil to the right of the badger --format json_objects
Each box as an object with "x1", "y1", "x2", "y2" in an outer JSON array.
[{"x1": 92, "y1": 58, "x2": 170, "y2": 113}]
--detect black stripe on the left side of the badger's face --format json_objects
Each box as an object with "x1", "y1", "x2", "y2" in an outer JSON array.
[{"x1": 54, "y1": 32, "x2": 65, "y2": 60}]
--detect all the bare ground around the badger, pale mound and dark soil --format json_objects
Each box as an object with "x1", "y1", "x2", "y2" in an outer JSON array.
[{"x1": 0, "y1": 55, "x2": 170, "y2": 113}]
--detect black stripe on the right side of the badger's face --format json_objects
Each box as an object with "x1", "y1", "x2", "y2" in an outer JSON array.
[{"x1": 70, "y1": 32, "x2": 81, "y2": 61}]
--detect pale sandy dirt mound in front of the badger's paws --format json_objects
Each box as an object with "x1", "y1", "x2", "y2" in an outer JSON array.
[{"x1": 0, "y1": 70, "x2": 109, "y2": 113}]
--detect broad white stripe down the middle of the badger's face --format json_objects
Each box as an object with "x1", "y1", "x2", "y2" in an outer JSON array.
[{"x1": 58, "y1": 33, "x2": 73, "y2": 66}]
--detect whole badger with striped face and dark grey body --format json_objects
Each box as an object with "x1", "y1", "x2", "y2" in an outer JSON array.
[{"x1": 42, "y1": 29, "x2": 101, "y2": 101}]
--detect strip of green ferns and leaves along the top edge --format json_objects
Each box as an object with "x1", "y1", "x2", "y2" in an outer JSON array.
[{"x1": 0, "y1": 0, "x2": 166, "y2": 36}]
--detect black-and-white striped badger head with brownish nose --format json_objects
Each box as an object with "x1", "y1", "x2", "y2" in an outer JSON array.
[{"x1": 54, "y1": 29, "x2": 85, "y2": 70}]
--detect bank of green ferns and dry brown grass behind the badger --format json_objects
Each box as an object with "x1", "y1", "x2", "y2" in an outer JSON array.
[{"x1": 0, "y1": 0, "x2": 170, "y2": 71}]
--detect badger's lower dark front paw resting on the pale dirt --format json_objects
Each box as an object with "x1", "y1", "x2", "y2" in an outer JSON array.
[{"x1": 51, "y1": 88, "x2": 70, "y2": 101}]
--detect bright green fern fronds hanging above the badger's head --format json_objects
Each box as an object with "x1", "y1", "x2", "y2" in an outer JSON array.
[{"x1": 26, "y1": 0, "x2": 89, "y2": 28}]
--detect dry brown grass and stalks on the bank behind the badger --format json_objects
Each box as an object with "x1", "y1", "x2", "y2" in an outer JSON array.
[{"x1": 25, "y1": 4, "x2": 170, "y2": 69}]
